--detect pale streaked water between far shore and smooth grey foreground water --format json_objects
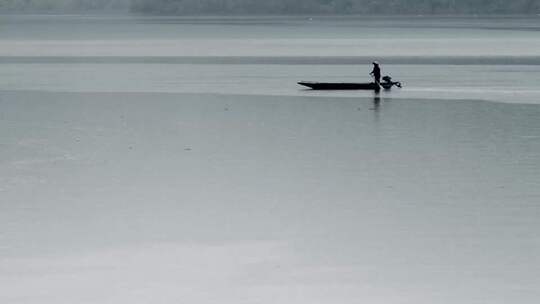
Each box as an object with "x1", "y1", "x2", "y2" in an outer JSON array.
[{"x1": 0, "y1": 16, "x2": 540, "y2": 103}]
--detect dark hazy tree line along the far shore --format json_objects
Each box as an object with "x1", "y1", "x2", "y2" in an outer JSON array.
[{"x1": 0, "y1": 0, "x2": 540, "y2": 15}]
